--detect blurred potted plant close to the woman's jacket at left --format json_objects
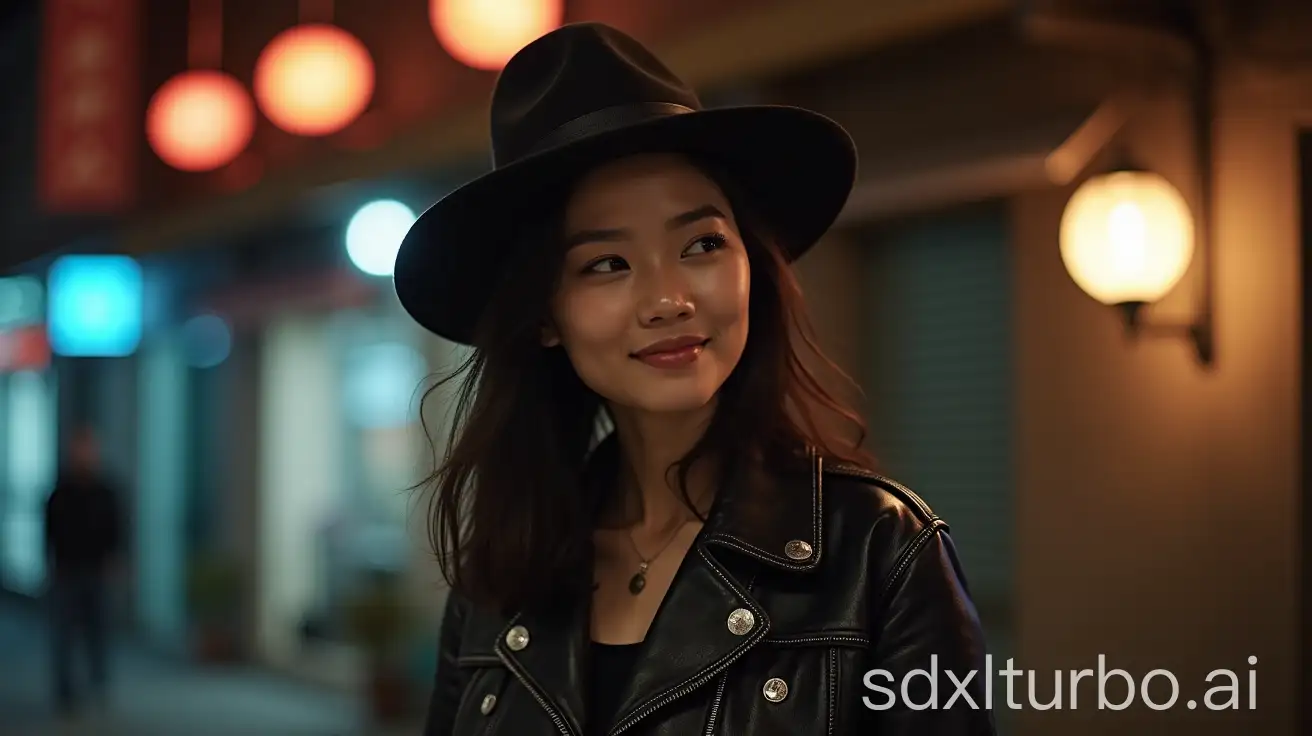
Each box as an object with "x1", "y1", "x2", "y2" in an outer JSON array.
[{"x1": 346, "y1": 572, "x2": 411, "y2": 723}]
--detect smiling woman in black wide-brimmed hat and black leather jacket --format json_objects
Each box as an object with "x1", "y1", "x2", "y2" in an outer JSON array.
[{"x1": 395, "y1": 24, "x2": 993, "y2": 736}]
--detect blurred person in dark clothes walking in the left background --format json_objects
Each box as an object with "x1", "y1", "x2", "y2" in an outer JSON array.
[{"x1": 45, "y1": 428, "x2": 123, "y2": 714}]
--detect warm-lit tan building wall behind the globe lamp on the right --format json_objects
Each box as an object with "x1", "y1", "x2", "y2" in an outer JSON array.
[{"x1": 1013, "y1": 64, "x2": 1312, "y2": 736}]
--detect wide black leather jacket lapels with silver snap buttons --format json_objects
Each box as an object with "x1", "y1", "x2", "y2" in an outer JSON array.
[{"x1": 467, "y1": 440, "x2": 824, "y2": 736}]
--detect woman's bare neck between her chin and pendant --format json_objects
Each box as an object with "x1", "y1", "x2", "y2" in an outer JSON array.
[{"x1": 605, "y1": 404, "x2": 715, "y2": 530}]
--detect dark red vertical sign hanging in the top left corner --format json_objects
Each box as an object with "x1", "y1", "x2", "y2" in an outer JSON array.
[{"x1": 37, "y1": 0, "x2": 142, "y2": 214}]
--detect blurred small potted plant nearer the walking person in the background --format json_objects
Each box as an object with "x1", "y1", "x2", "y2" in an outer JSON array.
[{"x1": 186, "y1": 554, "x2": 241, "y2": 663}]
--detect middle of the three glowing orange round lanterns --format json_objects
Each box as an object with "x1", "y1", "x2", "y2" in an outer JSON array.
[{"x1": 255, "y1": 24, "x2": 374, "y2": 135}]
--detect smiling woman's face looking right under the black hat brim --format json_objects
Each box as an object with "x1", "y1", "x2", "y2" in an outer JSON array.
[{"x1": 544, "y1": 155, "x2": 750, "y2": 412}]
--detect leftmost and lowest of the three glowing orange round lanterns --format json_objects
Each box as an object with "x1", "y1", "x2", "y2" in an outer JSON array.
[{"x1": 146, "y1": 70, "x2": 255, "y2": 172}]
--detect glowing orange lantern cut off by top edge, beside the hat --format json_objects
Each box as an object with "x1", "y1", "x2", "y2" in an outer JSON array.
[{"x1": 428, "y1": 0, "x2": 564, "y2": 71}]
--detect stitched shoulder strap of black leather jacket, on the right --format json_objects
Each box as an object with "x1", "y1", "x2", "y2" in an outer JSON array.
[{"x1": 820, "y1": 460, "x2": 947, "y2": 530}]
